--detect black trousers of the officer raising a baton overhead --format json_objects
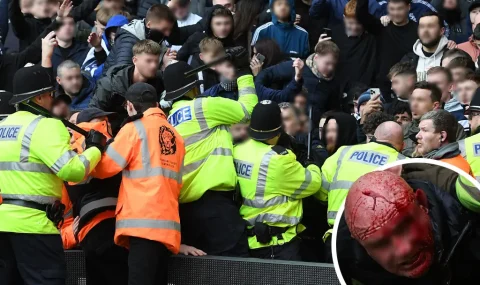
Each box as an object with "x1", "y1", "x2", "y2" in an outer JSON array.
[{"x1": 180, "y1": 191, "x2": 249, "y2": 257}]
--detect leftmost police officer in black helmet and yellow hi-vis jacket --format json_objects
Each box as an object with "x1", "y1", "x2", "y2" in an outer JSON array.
[{"x1": 0, "y1": 66, "x2": 106, "y2": 285}]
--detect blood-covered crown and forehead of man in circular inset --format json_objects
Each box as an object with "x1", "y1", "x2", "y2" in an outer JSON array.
[{"x1": 345, "y1": 171, "x2": 415, "y2": 240}]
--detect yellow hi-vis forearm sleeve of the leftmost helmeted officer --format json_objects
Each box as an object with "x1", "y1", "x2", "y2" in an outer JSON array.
[{"x1": 55, "y1": 147, "x2": 101, "y2": 182}]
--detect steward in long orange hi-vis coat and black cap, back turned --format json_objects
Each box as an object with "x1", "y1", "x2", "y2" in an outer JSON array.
[{"x1": 93, "y1": 83, "x2": 185, "y2": 285}]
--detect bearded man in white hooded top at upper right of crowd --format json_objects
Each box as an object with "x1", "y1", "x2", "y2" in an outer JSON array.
[{"x1": 402, "y1": 12, "x2": 448, "y2": 81}]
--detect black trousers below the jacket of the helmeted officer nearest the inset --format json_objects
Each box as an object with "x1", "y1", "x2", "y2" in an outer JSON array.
[{"x1": 250, "y1": 237, "x2": 302, "y2": 261}]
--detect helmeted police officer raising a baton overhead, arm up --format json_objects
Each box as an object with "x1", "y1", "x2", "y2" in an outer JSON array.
[{"x1": 164, "y1": 49, "x2": 258, "y2": 256}]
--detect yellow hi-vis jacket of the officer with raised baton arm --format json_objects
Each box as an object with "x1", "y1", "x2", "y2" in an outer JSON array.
[{"x1": 168, "y1": 75, "x2": 258, "y2": 203}]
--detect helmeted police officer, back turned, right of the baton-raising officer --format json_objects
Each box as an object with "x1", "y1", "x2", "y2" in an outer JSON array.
[{"x1": 233, "y1": 101, "x2": 321, "y2": 260}]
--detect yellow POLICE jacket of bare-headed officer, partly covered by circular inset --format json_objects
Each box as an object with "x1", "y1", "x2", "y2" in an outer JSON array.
[{"x1": 315, "y1": 142, "x2": 405, "y2": 226}]
